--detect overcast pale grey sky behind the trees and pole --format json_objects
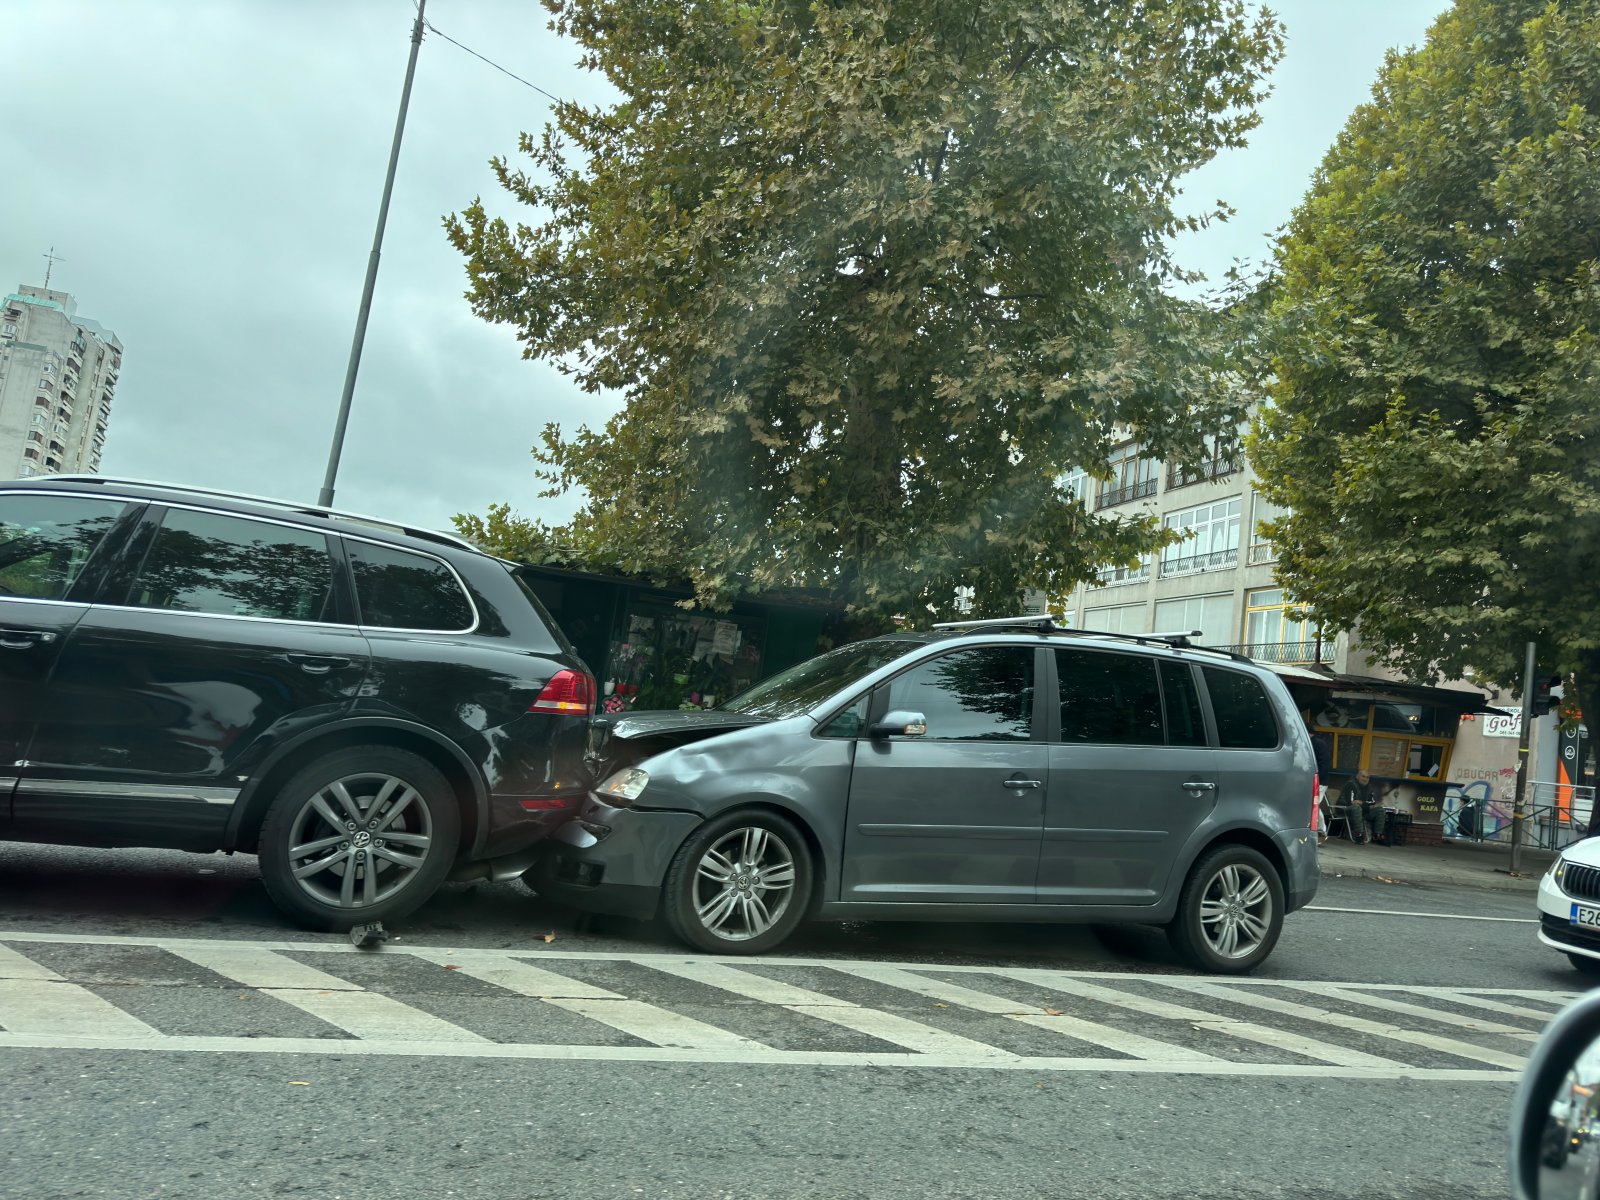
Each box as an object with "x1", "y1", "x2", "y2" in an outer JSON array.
[{"x1": 0, "y1": 0, "x2": 1448, "y2": 528}]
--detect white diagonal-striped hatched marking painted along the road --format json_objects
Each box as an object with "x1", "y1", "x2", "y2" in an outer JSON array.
[{"x1": 0, "y1": 931, "x2": 1574, "y2": 1082}]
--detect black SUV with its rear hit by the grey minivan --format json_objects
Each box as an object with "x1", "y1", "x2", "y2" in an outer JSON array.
[{"x1": 0, "y1": 477, "x2": 595, "y2": 928}]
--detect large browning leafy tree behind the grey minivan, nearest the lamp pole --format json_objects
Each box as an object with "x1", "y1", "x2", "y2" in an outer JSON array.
[{"x1": 446, "y1": 0, "x2": 1280, "y2": 624}]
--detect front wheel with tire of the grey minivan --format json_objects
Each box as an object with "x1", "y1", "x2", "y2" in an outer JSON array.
[{"x1": 662, "y1": 811, "x2": 811, "y2": 954}]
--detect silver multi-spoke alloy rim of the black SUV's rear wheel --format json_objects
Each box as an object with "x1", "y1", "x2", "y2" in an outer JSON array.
[{"x1": 288, "y1": 773, "x2": 434, "y2": 909}]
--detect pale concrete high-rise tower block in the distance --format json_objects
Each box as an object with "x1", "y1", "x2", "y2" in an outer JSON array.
[{"x1": 0, "y1": 285, "x2": 122, "y2": 478}]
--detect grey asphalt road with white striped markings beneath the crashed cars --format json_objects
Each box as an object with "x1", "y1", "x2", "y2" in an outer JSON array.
[{"x1": 0, "y1": 845, "x2": 1582, "y2": 1200}]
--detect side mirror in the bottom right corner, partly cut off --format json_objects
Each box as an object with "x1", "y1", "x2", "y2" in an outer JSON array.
[{"x1": 1510, "y1": 992, "x2": 1600, "y2": 1200}]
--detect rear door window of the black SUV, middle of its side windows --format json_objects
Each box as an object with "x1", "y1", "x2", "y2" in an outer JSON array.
[{"x1": 128, "y1": 509, "x2": 333, "y2": 621}]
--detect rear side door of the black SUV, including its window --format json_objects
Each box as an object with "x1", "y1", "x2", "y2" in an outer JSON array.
[{"x1": 13, "y1": 509, "x2": 370, "y2": 848}]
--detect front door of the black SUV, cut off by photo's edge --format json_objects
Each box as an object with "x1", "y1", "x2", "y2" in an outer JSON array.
[{"x1": 0, "y1": 491, "x2": 128, "y2": 829}]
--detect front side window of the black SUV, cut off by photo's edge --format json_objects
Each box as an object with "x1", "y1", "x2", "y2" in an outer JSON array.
[{"x1": 0, "y1": 493, "x2": 128, "y2": 600}]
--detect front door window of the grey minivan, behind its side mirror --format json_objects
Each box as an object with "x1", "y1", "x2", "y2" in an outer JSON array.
[{"x1": 888, "y1": 646, "x2": 1034, "y2": 741}]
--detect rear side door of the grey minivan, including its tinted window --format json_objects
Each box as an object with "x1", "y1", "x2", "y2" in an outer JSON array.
[{"x1": 1038, "y1": 648, "x2": 1218, "y2": 904}]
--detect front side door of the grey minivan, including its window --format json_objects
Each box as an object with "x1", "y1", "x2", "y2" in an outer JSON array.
[{"x1": 840, "y1": 646, "x2": 1050, "y2": 904}]
